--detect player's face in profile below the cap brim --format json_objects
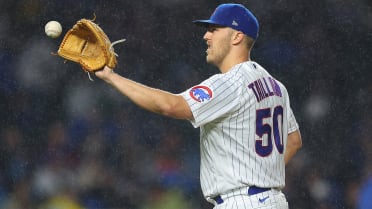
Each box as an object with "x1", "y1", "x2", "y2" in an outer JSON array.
[{"x1": 204, "y1": 25, "x2": 232, "y2": 67}]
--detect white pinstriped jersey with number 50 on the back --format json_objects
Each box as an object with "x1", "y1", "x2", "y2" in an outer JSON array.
[{"x1": 181, "y1": 61, "x2": 298, "y2": 197}]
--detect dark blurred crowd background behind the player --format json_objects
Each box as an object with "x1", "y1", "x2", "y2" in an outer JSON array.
[{"x1": 0, "y1": 0, "x2": 372, "y2": 209}]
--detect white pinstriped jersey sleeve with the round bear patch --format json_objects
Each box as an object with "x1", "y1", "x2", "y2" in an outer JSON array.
[{"x1": 181, "y1": 74, "x2": 241, "y2": 128}]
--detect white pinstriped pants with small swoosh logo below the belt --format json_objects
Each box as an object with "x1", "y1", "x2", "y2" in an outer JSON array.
[{"x1": 213, "y1": 189, "x2": 288, "y2": 209}]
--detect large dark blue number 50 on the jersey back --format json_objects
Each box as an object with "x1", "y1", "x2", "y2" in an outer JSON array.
[{"x1": 255, "y1": 106, "x2": 284, "y2": 157}]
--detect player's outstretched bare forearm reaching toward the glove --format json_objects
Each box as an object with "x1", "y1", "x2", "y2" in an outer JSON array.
[{"x1": 95, "y1": 67, "x2": 193, "y2": 120}]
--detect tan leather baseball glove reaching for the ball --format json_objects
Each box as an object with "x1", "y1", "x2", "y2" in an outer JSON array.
[{"x1": 58, "y1": 19, "x2": 125, "y2": 73}]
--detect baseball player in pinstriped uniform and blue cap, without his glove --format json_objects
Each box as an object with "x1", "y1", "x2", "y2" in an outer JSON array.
[{"x1": 95, "y1": 4, "x2": 302, "y2": 209}]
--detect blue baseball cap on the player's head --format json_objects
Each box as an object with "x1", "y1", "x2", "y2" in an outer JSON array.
[{"x1": 193, "y1": 3, "x2": 259, "y2": 40}]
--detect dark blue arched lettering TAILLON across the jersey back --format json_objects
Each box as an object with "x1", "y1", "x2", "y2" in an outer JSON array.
[{"x1": 248, "y1": 77, "x2": 282, "y2": 102}]
